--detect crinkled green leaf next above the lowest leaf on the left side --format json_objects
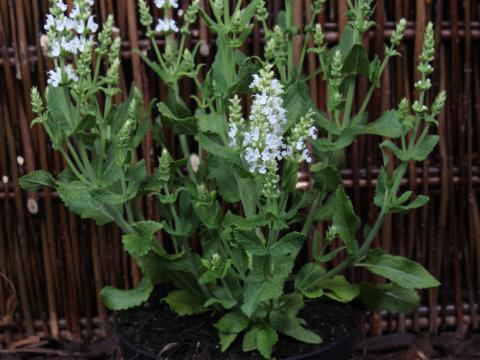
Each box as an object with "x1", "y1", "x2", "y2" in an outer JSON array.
[{"x1": 122, "y1": 221, "x2": 162, "y2": 257}]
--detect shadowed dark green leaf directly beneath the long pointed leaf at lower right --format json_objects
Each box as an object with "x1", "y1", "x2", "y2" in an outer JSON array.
[{"x1": 359, "y1": 282, "x2": 420, "y2": 313}]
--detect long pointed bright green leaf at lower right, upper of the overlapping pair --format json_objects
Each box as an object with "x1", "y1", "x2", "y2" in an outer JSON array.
[{"x1": 356, "y1": 249, "x2": 440, "y2": 289}]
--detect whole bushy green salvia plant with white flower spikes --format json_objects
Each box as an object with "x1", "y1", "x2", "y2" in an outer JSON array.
[{"x1": 21, "y1": 0, "x2": 446, "y2": 358}]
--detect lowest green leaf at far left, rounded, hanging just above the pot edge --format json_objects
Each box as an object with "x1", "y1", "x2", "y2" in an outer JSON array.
[{"x1": 100, "y1": 277, "x2": 153, "y2": 310}]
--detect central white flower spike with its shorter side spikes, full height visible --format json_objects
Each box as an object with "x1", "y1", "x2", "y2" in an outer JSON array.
[{"x1": 228, "y1": 64, "x2": 316, "y2": 190}]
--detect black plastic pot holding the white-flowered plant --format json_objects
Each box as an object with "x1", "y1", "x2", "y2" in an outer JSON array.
[{"x1": 118, "y1": 329, "x2": 359, "y2": 360}]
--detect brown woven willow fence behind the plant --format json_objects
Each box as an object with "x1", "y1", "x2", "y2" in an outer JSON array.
[{"x1": 0, "y1": 0, "x2": 480, "y2": 344}]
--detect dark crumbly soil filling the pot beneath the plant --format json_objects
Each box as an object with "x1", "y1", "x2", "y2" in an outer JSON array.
[{"x1": 115, "y1": 290, "x2": 359, "y2": 360}]
